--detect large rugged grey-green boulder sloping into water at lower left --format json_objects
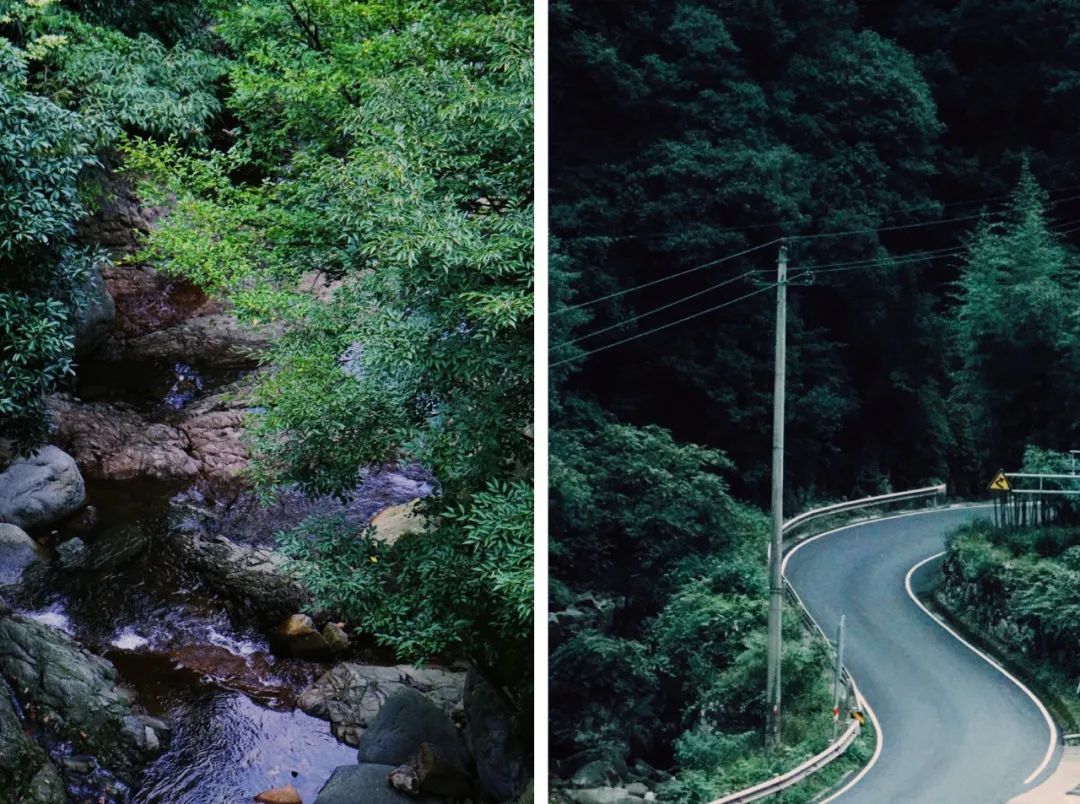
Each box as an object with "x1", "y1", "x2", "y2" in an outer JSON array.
[{"x1": 0, "y1": 615, "x2": 167, "y2": 780}]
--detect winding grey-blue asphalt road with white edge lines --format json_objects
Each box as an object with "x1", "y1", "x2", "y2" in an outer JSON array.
[{"x1": 785, "y1": 509, "x2": 1059, "y2": 804}]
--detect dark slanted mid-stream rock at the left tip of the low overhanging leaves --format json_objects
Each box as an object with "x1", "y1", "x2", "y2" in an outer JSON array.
[{"x1": 167, "y1": 530, "x2": 308, "y2": 624}]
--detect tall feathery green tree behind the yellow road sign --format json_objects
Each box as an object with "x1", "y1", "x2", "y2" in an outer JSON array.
[{"x1": 955, "y1": 166, "x2": 1080, "y2": 474}]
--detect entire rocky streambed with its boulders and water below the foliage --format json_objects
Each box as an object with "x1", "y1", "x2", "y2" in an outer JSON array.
[{"x1": 0, "y1": 183, "x2": 526, "y2": 804}]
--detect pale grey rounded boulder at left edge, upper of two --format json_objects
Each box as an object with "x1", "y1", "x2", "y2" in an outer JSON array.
[{"x1": 0, "y1": 446, "x2": 86, "y2": 527}]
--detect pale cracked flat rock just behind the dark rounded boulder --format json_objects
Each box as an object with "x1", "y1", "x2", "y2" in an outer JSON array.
[{"x1": 297, "y1": 661, "x2": 465, "y2": 746}]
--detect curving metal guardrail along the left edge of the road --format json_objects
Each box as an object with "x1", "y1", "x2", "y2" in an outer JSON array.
[{"x1": 710, "y1": 483, "x2": 945, "y2": 804}]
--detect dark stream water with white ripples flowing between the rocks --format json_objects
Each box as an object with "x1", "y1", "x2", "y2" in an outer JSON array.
[{"x1": 12, "y1": 354, "x2": 432, "y2": 804}]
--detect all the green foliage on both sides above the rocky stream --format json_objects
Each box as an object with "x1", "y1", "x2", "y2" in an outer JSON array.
[{"x1": 0, "y1": 0, "x2": 532, "y2": 706}]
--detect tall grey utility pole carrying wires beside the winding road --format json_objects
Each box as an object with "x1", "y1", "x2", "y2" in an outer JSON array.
[{"x1": 765, "y1": 243, "x2": 787, "y2": 748}]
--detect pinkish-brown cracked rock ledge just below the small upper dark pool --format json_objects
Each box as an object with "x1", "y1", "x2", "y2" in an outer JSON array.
[{"x1": 48, "y1": 389, "x2": 247, "y2": 480}]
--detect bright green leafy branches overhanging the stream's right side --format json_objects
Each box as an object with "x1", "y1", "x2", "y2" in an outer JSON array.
[{"x1": 124, "y1": 0, "x2": 532, "y2": 684}]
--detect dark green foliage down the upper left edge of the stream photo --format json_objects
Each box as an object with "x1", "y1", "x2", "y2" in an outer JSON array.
[{"x1": 0, "y1": 0, "x2": 220, "y2": 450}]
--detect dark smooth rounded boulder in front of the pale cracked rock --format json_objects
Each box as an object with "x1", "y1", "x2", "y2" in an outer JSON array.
[{"x1": 357, "y1": 687, "x2": 472, "y2": 792}]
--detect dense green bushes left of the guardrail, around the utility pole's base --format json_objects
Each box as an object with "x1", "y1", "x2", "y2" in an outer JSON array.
[{"x1": 550, "y1": 414, "x2": 846, "y2": 801}]
